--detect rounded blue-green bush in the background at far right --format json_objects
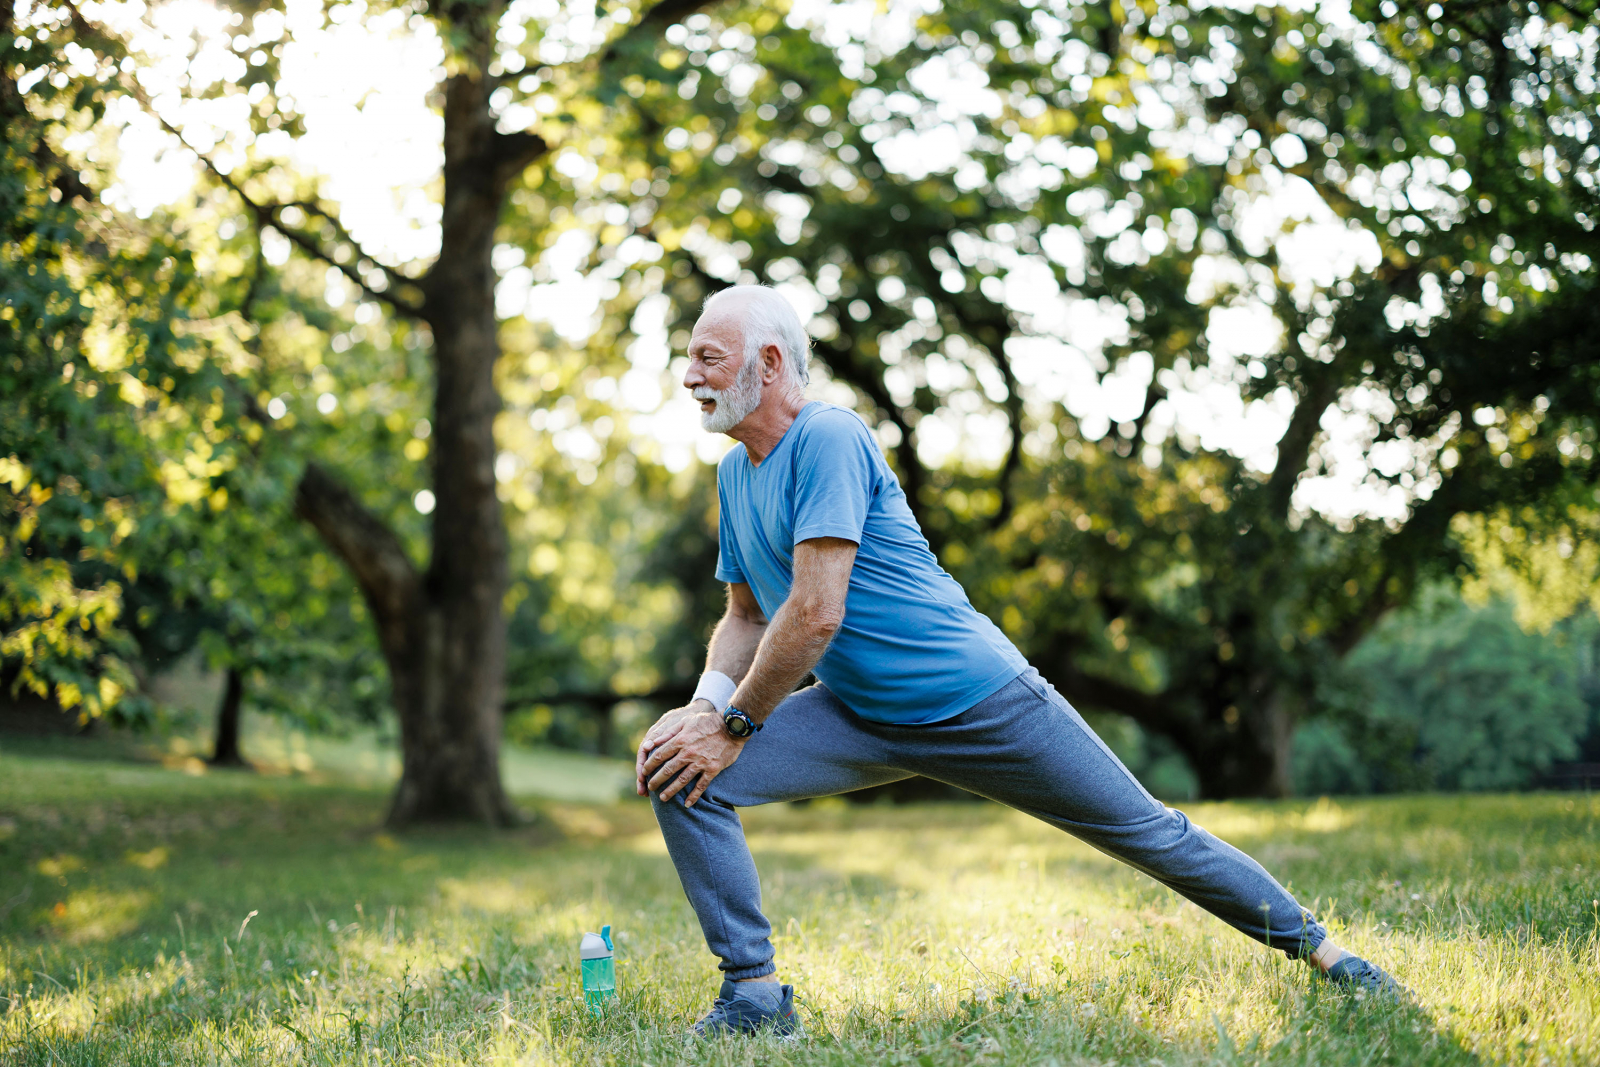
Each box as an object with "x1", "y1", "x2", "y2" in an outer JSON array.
[{"x1": 1296, "y1": 593, "x2": 1595, "y2": 792}]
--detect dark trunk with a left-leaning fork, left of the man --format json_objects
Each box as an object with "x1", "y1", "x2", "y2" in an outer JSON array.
[{"x1": 284, "y1": 64, "x2": 546, "y2": 827}]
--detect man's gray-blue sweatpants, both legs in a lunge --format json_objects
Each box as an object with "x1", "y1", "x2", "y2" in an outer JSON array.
[{"x1": 651, "y1": 669, "x2": 1326, "y2": 979}]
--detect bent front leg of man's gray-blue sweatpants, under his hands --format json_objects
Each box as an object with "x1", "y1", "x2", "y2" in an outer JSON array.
[{"x1": 650, "y1": 685, "x2": 909, "y2": 981}]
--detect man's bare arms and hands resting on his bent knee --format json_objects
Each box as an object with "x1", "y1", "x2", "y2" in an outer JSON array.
[{"x1": 635, "y1": 537, "x2": 856, "y2": 805}]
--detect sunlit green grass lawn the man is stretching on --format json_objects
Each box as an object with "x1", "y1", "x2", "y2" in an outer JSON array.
[{"x1": 0, "y1": 742, "x2": 1600, "y2": 1067}]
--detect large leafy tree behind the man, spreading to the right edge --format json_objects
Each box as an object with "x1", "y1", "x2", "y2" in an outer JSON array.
[{"x1": 515, "y1": 3, "x2": 1600, "y2": 797}]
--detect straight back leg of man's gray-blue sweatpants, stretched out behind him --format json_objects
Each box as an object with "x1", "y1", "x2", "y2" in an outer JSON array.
[{"x1": 894, "y1": 670, "x2": 1326, "y2": 958}]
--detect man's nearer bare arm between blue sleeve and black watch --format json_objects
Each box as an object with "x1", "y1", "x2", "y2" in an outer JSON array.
[{"x1": 729, "y1": 537, "x2": 856, "y2": 721}]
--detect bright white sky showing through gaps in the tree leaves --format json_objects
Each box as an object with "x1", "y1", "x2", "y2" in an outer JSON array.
[{"x1": 62, "y1": 0, "x2": 1491, "y2": 531}]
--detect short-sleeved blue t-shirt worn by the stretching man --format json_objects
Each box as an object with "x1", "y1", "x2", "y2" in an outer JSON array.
[{"x1": 717, "y1": 402, "x2": 1027, "y2": 725}]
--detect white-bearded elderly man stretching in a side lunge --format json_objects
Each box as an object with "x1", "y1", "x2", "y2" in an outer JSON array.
[{"x1": 635, "y1": 285, "x2": 1392, "y2": 1035}]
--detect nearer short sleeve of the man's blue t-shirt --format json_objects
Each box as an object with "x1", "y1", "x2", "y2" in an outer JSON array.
[{"x1": 794, "y1": 411, "x2": 883, "y2": 544}]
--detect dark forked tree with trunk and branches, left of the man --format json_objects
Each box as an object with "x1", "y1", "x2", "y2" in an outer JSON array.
[{"x1": 26, "y1": 0, "x2": 736, "y2": 825}]
